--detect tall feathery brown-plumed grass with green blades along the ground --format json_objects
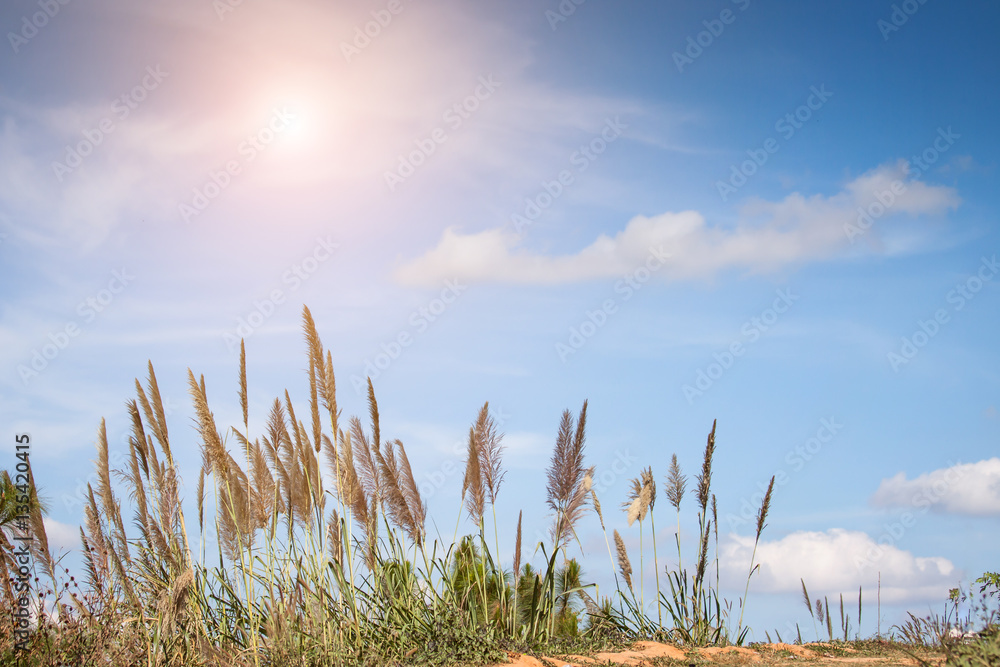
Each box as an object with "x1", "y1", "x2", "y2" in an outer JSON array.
[{"x1": 0, "y1": 308, "x2": 984, "y2": 667}]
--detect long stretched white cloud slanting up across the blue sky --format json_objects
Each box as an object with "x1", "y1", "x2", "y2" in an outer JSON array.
[{"x1": 395, "y1": 162, "x2": 959, "y2": 285}]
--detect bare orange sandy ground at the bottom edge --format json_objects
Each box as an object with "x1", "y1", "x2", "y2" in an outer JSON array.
[{"x1": 495, "y1": 642, "x2": 941, "y2": 667}]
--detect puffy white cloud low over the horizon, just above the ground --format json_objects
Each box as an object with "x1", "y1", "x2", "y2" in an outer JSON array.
[{"x1": 720, "y1": 528, "x2": 958, "y2": 603}]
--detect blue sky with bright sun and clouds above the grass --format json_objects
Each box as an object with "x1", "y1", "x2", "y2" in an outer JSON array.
[{"x1": 0, "y1": 0, "x2": 1000, "y2": 639}]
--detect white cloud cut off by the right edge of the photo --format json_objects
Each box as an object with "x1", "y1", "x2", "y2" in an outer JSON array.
[{"x1": 870, "y1": 457, "x2": 1000, "y2": 516}]
